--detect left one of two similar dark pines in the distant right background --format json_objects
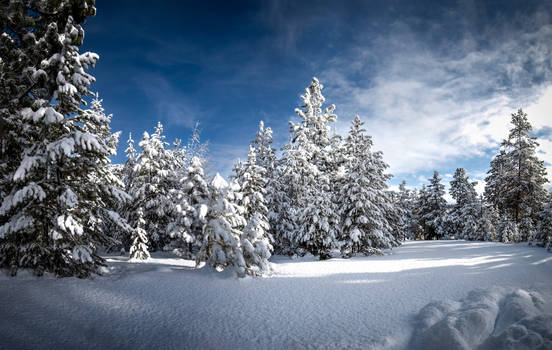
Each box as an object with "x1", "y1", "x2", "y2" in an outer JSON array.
[{"x1": 419, "y1": 171, "x2": 447, "y2": 239}]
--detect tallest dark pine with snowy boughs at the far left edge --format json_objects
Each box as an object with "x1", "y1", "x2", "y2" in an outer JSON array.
[{"x1": 0, "y1": 1, "x2": 127, "y2": 277}]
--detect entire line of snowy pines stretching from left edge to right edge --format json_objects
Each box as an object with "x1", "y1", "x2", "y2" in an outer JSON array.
[{"x1": 0, "y1": 0, "x2": 551, "y2": 277}]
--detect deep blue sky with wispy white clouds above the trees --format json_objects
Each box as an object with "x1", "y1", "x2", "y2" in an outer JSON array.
[{"x1": 82, "y1": 0, "x2": 552, "y2": 194}]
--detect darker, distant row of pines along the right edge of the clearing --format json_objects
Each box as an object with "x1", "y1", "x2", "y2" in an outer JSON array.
[{"x1": 396, "y1": 109, "x2": 552, "y2": 247}]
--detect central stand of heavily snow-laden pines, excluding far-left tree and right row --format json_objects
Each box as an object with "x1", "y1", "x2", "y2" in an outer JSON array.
[{"x1": 115, "y1": 78, "x2": 405, "y2": 275}]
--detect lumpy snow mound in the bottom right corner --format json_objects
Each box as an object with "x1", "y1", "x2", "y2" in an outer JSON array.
[{"x1": 409, "y1": 288, "x2": 552, "y2": 350}]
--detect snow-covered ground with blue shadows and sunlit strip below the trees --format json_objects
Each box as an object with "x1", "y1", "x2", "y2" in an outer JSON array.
[{"x1": 0, "y1": 241, "x2": 552, "y2": 350}]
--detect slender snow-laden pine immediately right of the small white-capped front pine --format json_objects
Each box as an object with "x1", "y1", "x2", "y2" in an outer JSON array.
[{"x1": 237, "y1": 145, "x2": 272, "y2": 275}]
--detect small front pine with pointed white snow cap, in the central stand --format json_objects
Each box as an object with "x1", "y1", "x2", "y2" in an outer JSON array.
[{"x1": 196, "y1": 173, "x2": 246, "y2": 276}]
